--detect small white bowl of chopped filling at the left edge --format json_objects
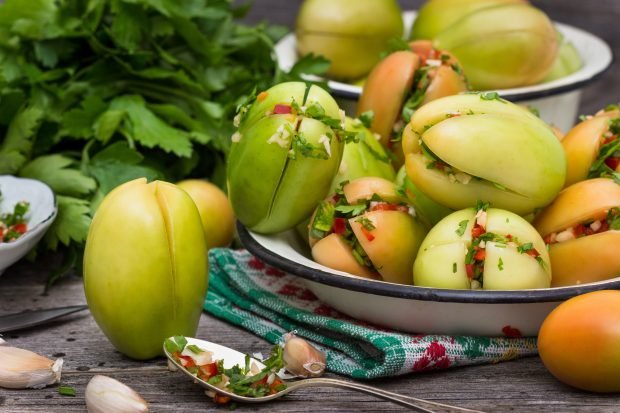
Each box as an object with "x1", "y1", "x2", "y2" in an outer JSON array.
[{"x1": 0, "y1": 175, "x2": 58, "y2": 274}]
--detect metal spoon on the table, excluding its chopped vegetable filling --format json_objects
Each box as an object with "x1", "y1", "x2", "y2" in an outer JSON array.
[{"x1": 164, "y1": 337, "x2": 481, "y2": 413}]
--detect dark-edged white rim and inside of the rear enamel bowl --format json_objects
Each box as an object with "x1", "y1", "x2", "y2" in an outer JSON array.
[{"x1": 275, "y1": 10, "x2": 614, "y2": 102}]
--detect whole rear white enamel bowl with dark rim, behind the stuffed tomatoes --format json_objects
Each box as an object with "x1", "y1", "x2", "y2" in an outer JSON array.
[{"x1": 276, "y1": 11, "x2": 613, "y2": 132}]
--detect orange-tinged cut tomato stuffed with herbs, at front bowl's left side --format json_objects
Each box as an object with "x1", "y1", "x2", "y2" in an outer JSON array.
[{"x1": 309, "y1": 177, "x2": 427, "y2": 285}]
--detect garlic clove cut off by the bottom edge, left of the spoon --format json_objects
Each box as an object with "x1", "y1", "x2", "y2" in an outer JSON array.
[{"x1": 85, "y1": 375, "x2": 149, "y2": 413}]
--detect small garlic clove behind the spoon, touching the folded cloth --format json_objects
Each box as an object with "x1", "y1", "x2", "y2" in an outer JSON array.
[{"x1": 283, "y1": 333, "x2": 325, "y2": 377}]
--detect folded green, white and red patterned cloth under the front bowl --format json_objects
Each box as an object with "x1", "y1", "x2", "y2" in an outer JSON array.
[{"x1": 204, "y1": 248, "x2": 537, "y2": 379}]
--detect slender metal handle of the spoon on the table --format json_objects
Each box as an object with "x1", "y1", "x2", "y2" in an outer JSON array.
[{"x1": 280, "y1": 377, "x2": 481, "y2": 413}]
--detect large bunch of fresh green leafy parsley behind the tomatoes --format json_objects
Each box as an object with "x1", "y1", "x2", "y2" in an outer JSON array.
[{"x1": 0, "y1": 0, "x2": 326, "y2": 284}]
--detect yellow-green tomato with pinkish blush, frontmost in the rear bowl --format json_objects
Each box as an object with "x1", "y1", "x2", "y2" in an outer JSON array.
[{"x1": 433, "y1": 3, "x2": 559, "y2": 90}]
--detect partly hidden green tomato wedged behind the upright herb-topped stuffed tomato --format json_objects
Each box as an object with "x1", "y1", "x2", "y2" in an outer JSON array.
[{"x1": 329, "y1": 117, "x2": 396, "y2": 193}]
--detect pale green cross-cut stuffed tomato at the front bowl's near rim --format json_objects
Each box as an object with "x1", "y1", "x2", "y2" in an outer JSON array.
[{"x1": 413, "y1": 208, "x2": 551, "y2": 290}]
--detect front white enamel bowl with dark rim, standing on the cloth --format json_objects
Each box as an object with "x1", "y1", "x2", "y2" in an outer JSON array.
[{"x1": 238, "y1": 224, "x2": 620, "y2": 336}]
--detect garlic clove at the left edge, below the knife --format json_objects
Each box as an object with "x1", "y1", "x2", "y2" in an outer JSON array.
[{"x1": 0, "y1": 346, "x2": 62, "y2": 389}]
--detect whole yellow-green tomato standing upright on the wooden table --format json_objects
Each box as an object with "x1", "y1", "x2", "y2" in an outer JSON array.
[{"x1": 84, "y1": 178, "x2": 208, "y2": 359}]
